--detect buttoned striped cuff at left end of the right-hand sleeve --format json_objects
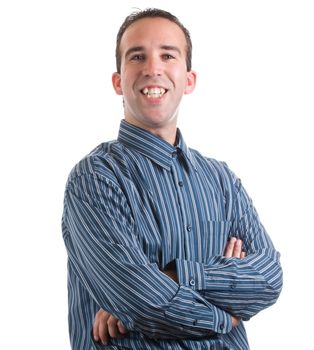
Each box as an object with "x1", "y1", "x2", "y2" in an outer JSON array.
[{"x1": 175, "y1": 259, "x2": 206, "y2": 291}]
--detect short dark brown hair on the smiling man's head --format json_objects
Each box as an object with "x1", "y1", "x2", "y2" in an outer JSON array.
[{"x1": 116, "y1": 8, "x2": 192, "y2": 73}]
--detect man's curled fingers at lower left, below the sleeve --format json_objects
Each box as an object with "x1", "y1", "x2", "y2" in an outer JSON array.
[{"x1": 93, "y1": 309, "x2": 127, "y2": 345}]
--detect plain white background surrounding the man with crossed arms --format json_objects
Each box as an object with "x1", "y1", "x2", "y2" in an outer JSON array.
[{"x1": 0, "y1": 0, "x2": 314, "y2": 350}]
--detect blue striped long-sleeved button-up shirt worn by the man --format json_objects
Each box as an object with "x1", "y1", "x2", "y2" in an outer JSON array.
[{"x1": 62, "y1": 121, "x2": 282, "y2": 350}]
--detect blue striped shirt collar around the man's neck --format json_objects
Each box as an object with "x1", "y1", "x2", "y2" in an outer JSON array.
[{"x1": 118, "y1": 120, "x2": 195, "y2": 170}]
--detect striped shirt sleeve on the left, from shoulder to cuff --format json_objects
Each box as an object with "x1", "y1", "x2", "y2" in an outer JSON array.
[{"x1": 63, "y1": 169, "x2": 232, "y2": 338}]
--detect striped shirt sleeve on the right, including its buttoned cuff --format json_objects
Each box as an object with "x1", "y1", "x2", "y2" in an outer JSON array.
[{"x1": 176, "y1": 168, "x2": 282, "y2": 320}]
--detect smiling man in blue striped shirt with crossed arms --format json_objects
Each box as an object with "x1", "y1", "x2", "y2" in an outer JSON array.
[{"x1": 63, "y1": 9, "x2": 282, "y2": 350}]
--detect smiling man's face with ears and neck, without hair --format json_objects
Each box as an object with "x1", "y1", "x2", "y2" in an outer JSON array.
[{"x1": 113, "y1": 17, "x2": 196, "y2": 139}]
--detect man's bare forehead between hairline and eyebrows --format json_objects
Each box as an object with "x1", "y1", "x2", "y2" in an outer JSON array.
[{"x1": 120, "y1": 17, "x2": 186, "y2": 54}]
